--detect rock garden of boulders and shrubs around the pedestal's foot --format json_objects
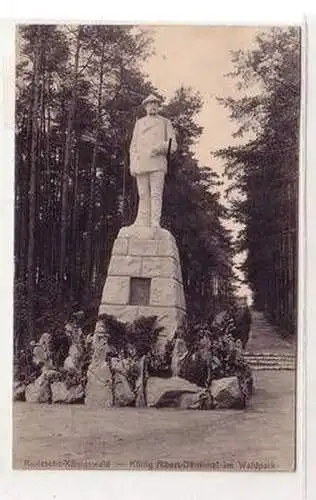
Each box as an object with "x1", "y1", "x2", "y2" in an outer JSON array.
[{"x1": 13, "y1": 312, "x2": 253, "y2": 410}]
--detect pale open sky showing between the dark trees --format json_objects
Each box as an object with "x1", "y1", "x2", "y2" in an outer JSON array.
[{"x1": 144, "y1": 25, "x2": 263, "y2": 298}]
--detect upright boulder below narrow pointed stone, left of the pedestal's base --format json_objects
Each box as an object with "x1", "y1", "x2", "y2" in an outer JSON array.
[{"x1": 85, "y1": 361, "x2": 113, "y2": 408}]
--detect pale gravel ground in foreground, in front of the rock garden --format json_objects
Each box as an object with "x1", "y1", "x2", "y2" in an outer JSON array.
[{"x1": 13, "y1": 372, "x2": 295, "y2": 471}]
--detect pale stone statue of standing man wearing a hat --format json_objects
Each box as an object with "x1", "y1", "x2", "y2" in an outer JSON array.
[{"x1": 130, "y1": 95, "x2": 177, "y2": 228}]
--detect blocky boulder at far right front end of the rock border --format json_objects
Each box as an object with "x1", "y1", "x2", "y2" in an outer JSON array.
[{"x1": 211, "y1": 377, "x2": 244, "y2": 409}]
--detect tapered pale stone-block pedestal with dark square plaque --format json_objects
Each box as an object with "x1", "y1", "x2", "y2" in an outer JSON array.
[{"x1": 99, "y1": 226, "x2": 185, "y2": 341}]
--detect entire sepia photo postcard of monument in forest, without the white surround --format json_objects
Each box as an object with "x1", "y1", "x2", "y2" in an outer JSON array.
[{"x1": 12, "y1": 23, "x2": 302, "y2": 473}]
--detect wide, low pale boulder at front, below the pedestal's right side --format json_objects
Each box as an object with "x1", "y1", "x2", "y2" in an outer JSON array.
[{"x1": 147, "y1": 377, "x2": 203, "y2": 408}]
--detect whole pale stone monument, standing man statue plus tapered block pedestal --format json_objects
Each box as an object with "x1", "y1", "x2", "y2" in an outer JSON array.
[{"x1": 88, "y1": 95, "x2": 186, "y2": 406}]
